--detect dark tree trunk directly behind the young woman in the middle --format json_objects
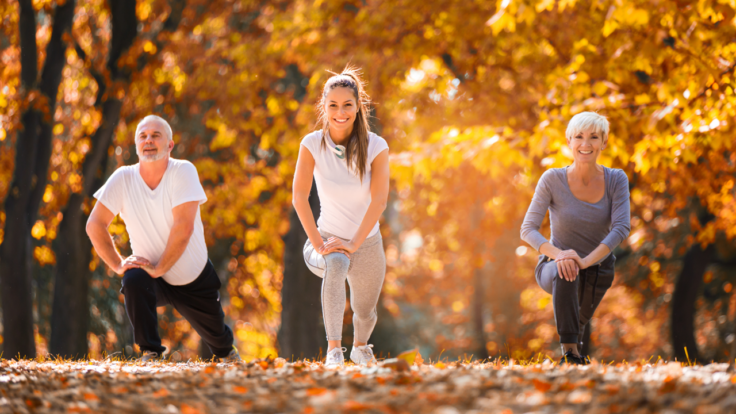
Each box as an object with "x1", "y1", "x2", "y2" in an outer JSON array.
[{"x1": 278, "y1": 183, "x2": 327, "y2": 359}]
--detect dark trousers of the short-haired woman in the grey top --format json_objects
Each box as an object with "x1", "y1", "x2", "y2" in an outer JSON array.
[{"x1": 535, "y1": 254, "x2": 616, "y2": 345}]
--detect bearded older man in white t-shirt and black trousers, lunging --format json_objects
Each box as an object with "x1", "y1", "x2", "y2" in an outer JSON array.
[{"x1": 87, "y1": 115, "x2": 240, "y2": 362}]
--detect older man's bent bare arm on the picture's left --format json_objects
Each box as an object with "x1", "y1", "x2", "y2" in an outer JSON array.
[{"x1": 86, "y1": 201, "x2": 148, "y2": 275}]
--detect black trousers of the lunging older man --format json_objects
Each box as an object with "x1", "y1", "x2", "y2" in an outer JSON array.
[{"x1": 120, "y1": 260, "x2": 233, "y2": 358}]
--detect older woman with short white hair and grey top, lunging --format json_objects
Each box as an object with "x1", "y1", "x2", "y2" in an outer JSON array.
[{"x1": 521, "y1": 112, "x2": 630, "y2": 364}]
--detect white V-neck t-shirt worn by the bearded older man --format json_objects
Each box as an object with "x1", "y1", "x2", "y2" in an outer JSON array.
[{"x1": 95, "y1": 158, "x2": 207, "y2": 285}]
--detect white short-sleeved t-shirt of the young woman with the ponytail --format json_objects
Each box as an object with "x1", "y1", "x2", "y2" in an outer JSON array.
[{"x1": 301, "y1": 130, "x2": 388, "y2": 240}]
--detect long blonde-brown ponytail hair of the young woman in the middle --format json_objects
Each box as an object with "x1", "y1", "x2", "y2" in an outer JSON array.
[{"x1": 317, "y1": 65, "x2": 370, "y2": 181}]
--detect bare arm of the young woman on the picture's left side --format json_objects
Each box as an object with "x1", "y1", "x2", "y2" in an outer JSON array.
[{"x1": 291, "y1": 145, "x2": 324, "y2": 254}]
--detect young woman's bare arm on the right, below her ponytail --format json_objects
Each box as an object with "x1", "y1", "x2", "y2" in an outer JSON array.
[{"x1": 325, "y1": 148, "x2": 389, "y2": 253}]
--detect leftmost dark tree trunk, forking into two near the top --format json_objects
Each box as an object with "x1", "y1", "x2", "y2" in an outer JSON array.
[{"x1": 0, "y1": 0, "x2": 75, "y2": 358}]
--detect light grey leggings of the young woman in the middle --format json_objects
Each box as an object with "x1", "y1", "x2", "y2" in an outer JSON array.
[{"x1": 306, "y1": 231, "x2": 386, "y2": 343}]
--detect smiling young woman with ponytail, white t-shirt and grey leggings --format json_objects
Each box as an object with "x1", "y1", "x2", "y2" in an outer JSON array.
[{"x1": 293, "y1": 67, "x2": 389, "y2": 366}]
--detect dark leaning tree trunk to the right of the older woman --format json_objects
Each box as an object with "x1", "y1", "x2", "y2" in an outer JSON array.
[{"x1": 670, "y1": 244, "x2": 715, "y2": 361}]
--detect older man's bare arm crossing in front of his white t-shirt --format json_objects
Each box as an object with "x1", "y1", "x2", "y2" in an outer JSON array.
[{"x1": 141, "y1": 201, "x2": 199, "y2": 278}]
